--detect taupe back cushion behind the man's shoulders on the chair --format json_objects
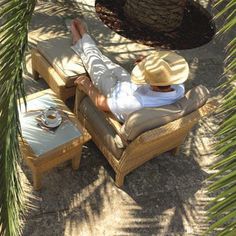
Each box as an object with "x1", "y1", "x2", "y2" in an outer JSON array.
[{"x1": 121, "y1": 85, "x2": 209, "y2": 141}]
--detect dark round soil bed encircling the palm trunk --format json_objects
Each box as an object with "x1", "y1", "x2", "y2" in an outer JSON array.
[{"x1": 96, "y1": 0, "x2": 215, "y2": 49}]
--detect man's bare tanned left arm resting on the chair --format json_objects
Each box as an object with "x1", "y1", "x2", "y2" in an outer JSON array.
[{"x1": 75, "y1": 76, "x2": 110, "y2": 112}]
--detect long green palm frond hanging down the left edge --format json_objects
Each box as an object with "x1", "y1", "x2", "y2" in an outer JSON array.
[{"x1": 0, "y1": 0, "x2": 36, "y2": 236}]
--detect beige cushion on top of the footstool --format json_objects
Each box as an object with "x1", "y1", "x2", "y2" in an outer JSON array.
[{"x1": 37, "y1": 36, "x2": 86, "y2": 87}]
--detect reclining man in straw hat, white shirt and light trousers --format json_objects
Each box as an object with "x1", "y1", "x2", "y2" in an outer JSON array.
[{"x1": 71, "y1": 19, "x2": 189, "y2": 121}]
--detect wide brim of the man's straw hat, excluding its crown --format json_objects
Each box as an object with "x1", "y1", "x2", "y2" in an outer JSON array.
[{"x1": 131, "y1": 51, "x2": 189, "y2": 86}]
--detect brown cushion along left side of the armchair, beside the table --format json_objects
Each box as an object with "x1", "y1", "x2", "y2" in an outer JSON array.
[{"x1": 79, "y1": 97, "x2": 124, "y2": 159}]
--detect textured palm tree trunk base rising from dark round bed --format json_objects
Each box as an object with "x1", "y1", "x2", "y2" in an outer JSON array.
[{"x1": 124, "y1": 0, "x2": 187, "y2": 32}]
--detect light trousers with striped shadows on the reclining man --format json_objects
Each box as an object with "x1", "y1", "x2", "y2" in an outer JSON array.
[{"x1": 72, "y1": 34, "x2": 130, "y2": 97}]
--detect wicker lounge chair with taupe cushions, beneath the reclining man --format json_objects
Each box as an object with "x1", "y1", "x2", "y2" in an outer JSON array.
[{"x1": 75, "y1": 78, "x2": 216, "y2": 187}]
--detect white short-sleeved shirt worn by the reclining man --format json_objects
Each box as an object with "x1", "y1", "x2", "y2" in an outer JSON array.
[{"x1": 107, "y1": 82, "x2": 185, "y2": 121}]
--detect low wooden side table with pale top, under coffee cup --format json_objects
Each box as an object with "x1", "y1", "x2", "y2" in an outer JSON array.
[{"x1": 19, "y1": 89, "x2": 91, "y2": 190}]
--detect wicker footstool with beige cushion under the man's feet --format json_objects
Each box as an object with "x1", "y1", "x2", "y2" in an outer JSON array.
[{"x1": 31, "y1": 36, "x2": 86, "y2": 101}]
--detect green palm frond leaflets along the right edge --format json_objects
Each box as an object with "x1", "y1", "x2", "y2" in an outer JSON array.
[{"x1": 207, "y1": 0, "x2": 236, "y2": 236}]
